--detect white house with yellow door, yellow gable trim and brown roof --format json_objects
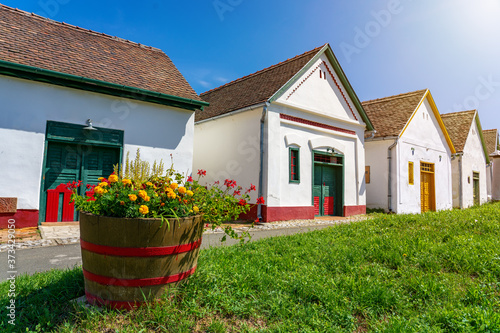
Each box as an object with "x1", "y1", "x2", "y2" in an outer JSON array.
[{"x1": 363, "y1": 90, "x2": 455, "y2": 213}]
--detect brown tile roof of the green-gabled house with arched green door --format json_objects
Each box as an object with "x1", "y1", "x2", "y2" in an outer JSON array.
[{"x1": 195, "y1": 46, "x2": 323, "y2": 121}]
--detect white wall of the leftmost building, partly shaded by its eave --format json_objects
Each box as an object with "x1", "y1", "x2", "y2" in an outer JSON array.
[{"x1": 0, "y1": 76, "x2": 194, "y2": 209}]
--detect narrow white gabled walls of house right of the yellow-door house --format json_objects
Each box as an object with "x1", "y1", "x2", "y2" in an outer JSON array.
[{"x1": 452, "y1": 121, "x2": 488, "y2": 208}]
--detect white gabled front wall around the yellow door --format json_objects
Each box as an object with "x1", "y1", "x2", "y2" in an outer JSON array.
[{"x1": 396, "y1": 100, "x2": 452, "y2": 213}]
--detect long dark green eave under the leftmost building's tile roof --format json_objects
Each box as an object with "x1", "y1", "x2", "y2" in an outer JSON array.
[{"x1": 0, "y1": 60, "x2": 209, "y2": 111}]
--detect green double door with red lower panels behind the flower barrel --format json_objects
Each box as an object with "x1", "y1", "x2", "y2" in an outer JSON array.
[{"x1": 41, "y1": 142, "x2": 120, "y2": 222}]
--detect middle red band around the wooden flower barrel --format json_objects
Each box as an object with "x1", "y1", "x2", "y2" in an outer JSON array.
[{"x1": 83, "y1": 266, "x2": 196, "y2": 287}]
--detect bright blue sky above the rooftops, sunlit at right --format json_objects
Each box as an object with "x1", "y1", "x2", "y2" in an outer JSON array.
[{"x1": 0, "y1": 0, "x2": 500, "y2": 129}]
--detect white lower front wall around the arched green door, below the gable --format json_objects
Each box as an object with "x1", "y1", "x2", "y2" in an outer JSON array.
[{"x1": 266, "y1": 104, "x2": 366, "y2": 207}]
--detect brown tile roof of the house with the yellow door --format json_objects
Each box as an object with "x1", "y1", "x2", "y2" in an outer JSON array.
[{"x1": 361, "y1": 89, "x2": 427, "y2": 138}]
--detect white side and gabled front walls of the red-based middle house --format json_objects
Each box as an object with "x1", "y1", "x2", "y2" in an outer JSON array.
[{"x1": 193, "y1": 54, "x2": 366, "y2": 218}]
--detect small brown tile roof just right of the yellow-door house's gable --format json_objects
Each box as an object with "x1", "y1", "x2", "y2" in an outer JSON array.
[{"x1": 441, "y1": 110, "x2": 476, "y2": 153}]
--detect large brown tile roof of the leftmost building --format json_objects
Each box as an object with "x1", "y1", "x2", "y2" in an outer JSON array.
[{"x1": 0, "y1": 5, "x2": 200, "y2": 100}]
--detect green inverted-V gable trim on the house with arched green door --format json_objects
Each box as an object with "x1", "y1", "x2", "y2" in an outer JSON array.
[{"x1": 269, "y1": 44, "x2": 374, "y2": 131}]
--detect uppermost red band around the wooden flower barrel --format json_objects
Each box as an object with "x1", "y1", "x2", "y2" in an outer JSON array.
[{"x1": 80, "y1": 238, "x2": 201, "y2": 257}]
